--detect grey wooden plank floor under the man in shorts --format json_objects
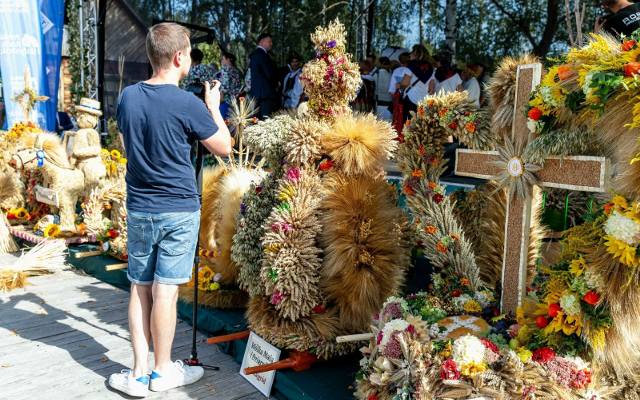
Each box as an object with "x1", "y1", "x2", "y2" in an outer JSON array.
[{"x1": 0, "y1": 260, "x2": 264, "y2": 400}]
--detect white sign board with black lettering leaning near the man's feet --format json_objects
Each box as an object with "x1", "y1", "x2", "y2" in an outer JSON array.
[{"x1": 240, "y1": 332, "x2": 280, "y2": 397}]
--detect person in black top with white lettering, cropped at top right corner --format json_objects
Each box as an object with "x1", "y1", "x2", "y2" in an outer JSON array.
[{"x1": 595, "y1": 0, "x2": 640, "y2": 37}]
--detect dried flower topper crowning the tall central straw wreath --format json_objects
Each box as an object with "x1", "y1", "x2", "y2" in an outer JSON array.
[{"x1": 300, "y1": 20, "x2": 362, "y2": 118}]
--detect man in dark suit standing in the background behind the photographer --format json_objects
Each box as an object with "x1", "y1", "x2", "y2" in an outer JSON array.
[{"x1": 249, "y1": 33, "x2": 279, "y2": 119}]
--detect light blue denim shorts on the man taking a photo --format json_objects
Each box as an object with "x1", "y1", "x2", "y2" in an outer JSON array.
[{"x1": 127, "y1": 211, "x2": 200, "y2": 285}]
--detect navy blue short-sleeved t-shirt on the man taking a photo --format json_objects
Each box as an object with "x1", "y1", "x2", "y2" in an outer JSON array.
[{"x1": 117, "y1": 82, "x2": 218, "y2": 213}]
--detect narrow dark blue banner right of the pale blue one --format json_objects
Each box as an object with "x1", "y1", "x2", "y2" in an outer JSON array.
[{"x1": 40, "y1": 0, "x2": 64, "y2": 131}]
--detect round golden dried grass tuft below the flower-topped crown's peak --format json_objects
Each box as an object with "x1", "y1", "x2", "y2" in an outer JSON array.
[{"x1": 322, "y1": 114, "x2": 397, "y2": 177}]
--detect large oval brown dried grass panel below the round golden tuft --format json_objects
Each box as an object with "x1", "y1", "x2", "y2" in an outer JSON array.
[{"x1": 320, "y1": 174, "x2": 410, "y2": 332}]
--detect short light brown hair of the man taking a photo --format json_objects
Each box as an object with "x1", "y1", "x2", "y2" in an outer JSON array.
[{"x1": 146, "y1": 22, "x2": 191, "y2": 70}]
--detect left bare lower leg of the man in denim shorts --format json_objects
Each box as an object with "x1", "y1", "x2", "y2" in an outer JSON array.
[{"x1": 129, "y1": 283, "x2": 153, "y2": 377}]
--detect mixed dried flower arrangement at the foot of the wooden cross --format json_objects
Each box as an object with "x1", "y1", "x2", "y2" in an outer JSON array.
[{"x1": 356, "y1": 295, "x2": 609, "y2": 400}]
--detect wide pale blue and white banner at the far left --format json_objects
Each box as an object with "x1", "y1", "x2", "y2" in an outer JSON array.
[{"x1": 0, "y1": 0, "x2": 46, "y2": 127}]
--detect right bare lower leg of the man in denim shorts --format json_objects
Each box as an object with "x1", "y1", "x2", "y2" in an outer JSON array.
[{"x1": 151, "y1": 281, "x2": 178, "y2": 374}]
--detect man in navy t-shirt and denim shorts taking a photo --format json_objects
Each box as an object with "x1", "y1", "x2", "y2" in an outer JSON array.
[{"x1": 109, "y1": 23, "x2": 232, "y2": 397}]
